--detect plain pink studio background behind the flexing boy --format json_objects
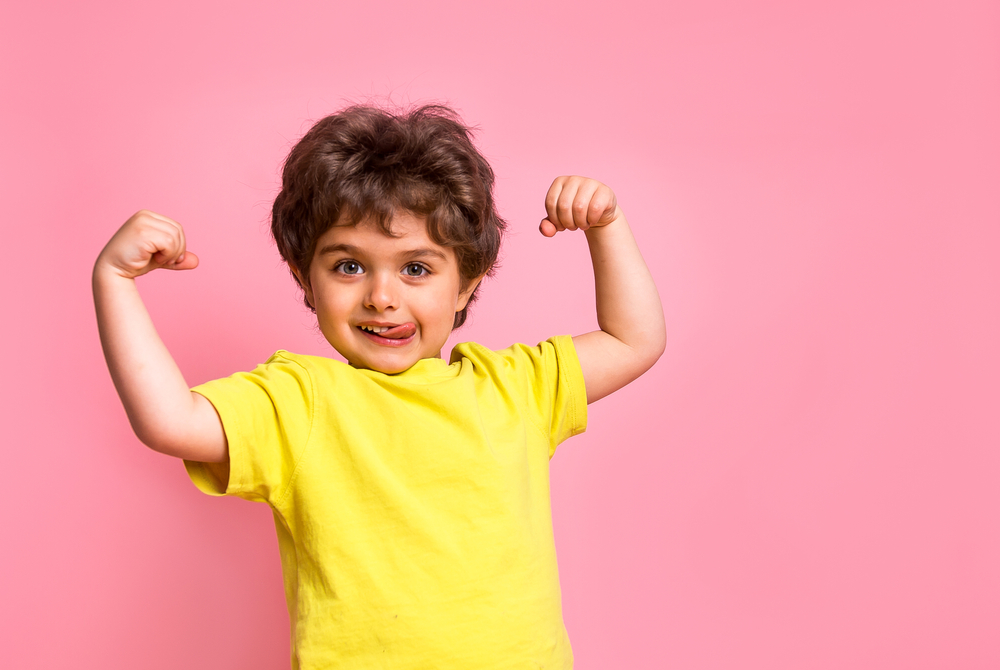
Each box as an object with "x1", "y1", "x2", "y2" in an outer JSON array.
[{"x1": 0, "y1": 0, "x2": 1000, "y2": 670}]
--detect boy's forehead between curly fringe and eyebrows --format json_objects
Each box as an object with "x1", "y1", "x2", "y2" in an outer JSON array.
[{"x1": 315, "y1": 212, "x2": 455, "y2": 263}]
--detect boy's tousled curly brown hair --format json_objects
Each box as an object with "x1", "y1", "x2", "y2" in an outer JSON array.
[{"x1": 271, "y1": 105, "x2": 506, "y2": 328}]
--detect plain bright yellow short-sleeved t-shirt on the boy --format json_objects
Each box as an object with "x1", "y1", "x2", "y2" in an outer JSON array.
[{"x1": 186, "y1": 337, "x2": 587, "y2": 670}]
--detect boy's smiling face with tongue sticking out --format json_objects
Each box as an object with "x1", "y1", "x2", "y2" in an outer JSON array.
[{"x1": 303, "y1": 212, "x2": 478, "y2": 374}]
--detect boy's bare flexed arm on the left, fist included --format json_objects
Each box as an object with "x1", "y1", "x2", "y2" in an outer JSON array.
[{"x1": 93, "y1": 211, "x2": 229, "y2": 463}]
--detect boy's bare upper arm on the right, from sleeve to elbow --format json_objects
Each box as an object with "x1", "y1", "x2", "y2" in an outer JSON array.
[{"x1": 573, "y1": 330, "x2": 663, "y2": 403}]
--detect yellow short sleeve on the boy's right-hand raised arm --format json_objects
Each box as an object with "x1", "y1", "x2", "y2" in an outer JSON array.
[{"x1": 497, "y1": 335, "x2": 587, "y2": 457}]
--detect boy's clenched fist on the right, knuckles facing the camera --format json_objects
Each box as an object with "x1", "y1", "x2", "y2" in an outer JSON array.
[{"x1": 538, "y1": 176, "x2": 621, "y2": 237}]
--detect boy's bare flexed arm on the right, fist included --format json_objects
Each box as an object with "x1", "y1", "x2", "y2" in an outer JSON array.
[{"x1": 539, "y1": 177, "x2": 667, "y2": 403}]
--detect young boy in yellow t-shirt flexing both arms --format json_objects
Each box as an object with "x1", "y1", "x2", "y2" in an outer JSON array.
[{"x1": 93, "y1": 107, "x2": 665, "y2": 670}]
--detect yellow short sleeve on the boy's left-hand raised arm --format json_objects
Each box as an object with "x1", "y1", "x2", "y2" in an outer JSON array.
[{"x1": 184, "y1": 351, "x2": 315, "y2": 502}]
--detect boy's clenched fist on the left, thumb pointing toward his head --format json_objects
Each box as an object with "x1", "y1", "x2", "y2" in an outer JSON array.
[{"x1": 97, "y1": 209, "x2": 198, "y2": 278}]
